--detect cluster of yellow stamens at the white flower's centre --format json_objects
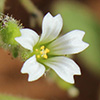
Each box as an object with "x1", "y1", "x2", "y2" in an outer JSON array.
[{"x1": 35, "y1": 45, "x2": 50, "y2": 59}]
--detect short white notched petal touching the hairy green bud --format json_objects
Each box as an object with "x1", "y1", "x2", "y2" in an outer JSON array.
[{"x1": 15, "y1": 28, "x2": 39, "y2": 51}]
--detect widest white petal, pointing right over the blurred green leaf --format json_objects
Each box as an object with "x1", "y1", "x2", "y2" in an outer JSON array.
[{"x1": 48, "y1": 30, "x2": 89, "y2": 55}]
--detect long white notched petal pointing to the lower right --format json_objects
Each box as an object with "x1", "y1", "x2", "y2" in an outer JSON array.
[{"x1": 44, "y1": 56, "x2": 81, "y2": 84}]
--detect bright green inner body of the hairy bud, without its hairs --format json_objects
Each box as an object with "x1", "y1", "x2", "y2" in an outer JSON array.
[{"x1": 1, "y1": 21, "x2": 21, "y2": 45}]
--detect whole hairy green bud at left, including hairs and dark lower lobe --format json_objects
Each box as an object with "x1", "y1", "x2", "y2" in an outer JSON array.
[{"x1": 0, "y1": 13, "x2": 22, "y2": 58}]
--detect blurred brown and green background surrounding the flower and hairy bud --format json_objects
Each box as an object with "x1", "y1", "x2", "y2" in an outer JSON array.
[{"x1": 0, "y1": 0, "x2": 100, "y2": 100}]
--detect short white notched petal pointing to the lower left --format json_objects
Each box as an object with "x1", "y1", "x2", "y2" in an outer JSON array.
[{"x1": 21, "y1": 55, "x2": 45, "y2": 81}]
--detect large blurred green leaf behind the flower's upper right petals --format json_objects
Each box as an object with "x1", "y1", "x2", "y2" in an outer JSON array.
[{"x1": 52, "y1": 1, "x2": 100, "y2": 76}]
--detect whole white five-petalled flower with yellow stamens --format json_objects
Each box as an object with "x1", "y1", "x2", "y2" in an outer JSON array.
[{"x1": 15, "y1": 13, "x2": 89, "y2": 83}]
